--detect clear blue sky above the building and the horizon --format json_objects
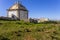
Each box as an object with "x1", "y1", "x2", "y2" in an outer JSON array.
[{"x1": 0, "y1": 0, "x2": 60, "y2": 20}]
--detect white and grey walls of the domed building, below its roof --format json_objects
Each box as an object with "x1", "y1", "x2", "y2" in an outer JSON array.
[{"x1": 8, "y1": 10, "x2": 28, "y2": 20}]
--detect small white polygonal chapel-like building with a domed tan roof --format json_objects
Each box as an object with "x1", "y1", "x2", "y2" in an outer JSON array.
[{"x1": 7, "y1": 2, "x2": 28, "y2": 21}]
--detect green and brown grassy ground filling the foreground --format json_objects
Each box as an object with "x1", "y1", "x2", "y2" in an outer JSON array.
[{"x1": 0, "y1": 20, "x2": 60, "y2": 40}]
